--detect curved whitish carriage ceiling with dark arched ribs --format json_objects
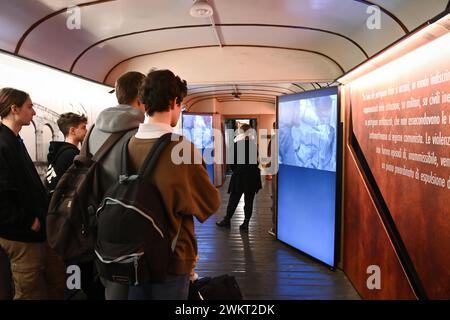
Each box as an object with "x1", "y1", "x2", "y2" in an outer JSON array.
[{"x1": 0, "y1": 0, "x2": 449, "y2": 107}]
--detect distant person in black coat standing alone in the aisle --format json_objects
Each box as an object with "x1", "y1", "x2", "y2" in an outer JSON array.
[{"x1": 216, "y1": 124, "x2": 262, "y2": 231}]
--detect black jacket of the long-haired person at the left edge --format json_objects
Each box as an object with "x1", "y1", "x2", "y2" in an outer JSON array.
[{"x1": 0, "y1": 124, "x2": 48, "y2": 242}]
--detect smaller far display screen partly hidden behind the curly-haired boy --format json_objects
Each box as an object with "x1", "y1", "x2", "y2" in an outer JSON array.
[{"x1": 182, "y1": 113, "x2": 214, "y2": 183}]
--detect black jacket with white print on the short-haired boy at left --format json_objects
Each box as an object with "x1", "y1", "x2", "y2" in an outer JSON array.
[{"x1": 45, "y1": 141, "x2": 80, "y2": 192}]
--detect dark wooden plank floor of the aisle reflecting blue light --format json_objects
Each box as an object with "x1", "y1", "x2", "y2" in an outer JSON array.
[{"x1": 196, "y1": 179, "x2": 360, "y2": 300}]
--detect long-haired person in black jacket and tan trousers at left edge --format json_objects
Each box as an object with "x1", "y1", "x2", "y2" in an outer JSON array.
[{"x1": 0, "y1": 88, "x2": 48, "y2": 299}]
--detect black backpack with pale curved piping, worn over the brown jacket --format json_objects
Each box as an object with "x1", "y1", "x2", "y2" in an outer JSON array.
[{"x1": 95, "y1": 133, "x2": 181, "y2": 285}]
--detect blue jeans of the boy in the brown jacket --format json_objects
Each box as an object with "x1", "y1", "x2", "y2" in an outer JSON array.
[{"x1": 128, "y1": 274, "x2": 189, "y2": 300}]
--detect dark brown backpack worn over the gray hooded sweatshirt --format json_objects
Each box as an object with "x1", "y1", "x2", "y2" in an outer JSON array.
[{"x1": 46, "y1": 128, "x2": 127, "y2": 262}]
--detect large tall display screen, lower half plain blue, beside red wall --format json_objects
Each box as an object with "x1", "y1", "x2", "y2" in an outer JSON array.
[{"x1": 277, "y1": 87, "x2": 338, "y2": 266}]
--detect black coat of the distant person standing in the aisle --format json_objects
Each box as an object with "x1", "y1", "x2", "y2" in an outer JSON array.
[{"x1": 228, "y1": 139, "x2": 262, "y2": 193}]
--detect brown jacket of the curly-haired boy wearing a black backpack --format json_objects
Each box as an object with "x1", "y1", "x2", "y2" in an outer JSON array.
[{"x1": 128, "y1": 137, "x2": 220, "y2": 274}]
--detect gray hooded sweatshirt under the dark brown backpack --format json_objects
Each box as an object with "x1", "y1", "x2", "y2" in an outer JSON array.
[{"x1": 88, "y1": 105, "x2": 145, "y2": 194}]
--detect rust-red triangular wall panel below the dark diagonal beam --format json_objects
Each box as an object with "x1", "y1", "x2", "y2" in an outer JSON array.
[{"x1": 344, "y1": 147, "x2": 416, "y2": 299}]
